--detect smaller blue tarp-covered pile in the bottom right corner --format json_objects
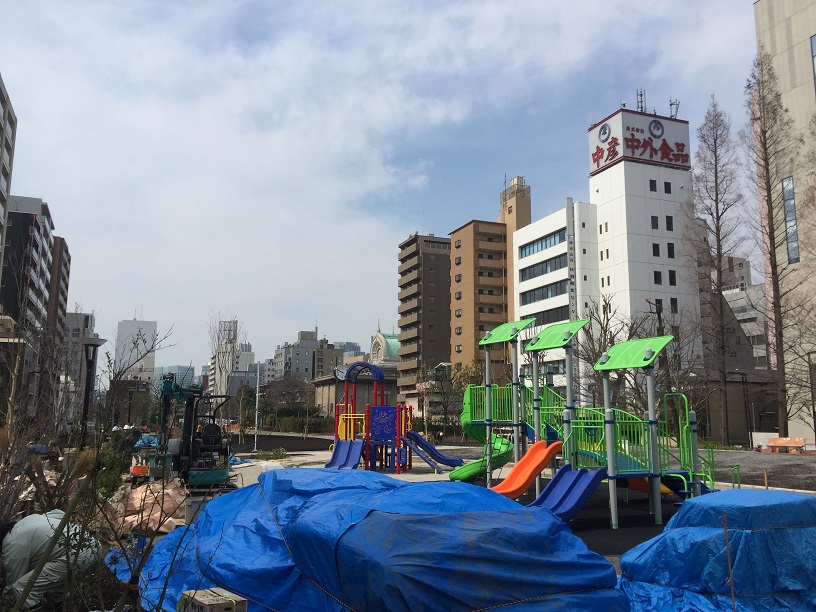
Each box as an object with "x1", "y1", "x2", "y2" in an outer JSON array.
[{"x1": 619, "y1": 489, "x2": 816, "y2": 611}]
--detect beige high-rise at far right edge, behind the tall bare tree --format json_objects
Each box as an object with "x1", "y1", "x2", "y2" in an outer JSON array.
[{"x1": 754, "y1": 0, "x2": 816, "y2": 444}]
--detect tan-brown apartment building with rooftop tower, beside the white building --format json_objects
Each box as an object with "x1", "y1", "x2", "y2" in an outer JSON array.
[{"x1": 450, "y1": 176, "x2": 532, "y2": 368}]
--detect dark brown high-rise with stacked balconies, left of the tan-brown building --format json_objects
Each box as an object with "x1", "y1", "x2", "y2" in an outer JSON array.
[{"x1": 396, "y1": 234, "x2": 451, "y2": 402}]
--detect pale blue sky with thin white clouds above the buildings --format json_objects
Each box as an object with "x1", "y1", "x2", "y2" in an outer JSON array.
[{"x1": 0, "y1": 0, "x2": 756, "y2": 372}]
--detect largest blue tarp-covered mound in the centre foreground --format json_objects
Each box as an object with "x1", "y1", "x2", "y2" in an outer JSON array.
[{"x1": 119, "y1": 469, "x2": 629, "y2": 611}]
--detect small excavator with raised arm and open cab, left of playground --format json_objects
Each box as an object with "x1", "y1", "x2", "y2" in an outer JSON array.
[{"x1": 156, "y1": 374, "x2": 235, "y2": 490}]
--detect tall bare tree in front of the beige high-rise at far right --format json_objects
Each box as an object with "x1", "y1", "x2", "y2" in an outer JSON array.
[{"x1": 741, "y1": 48, "x2": 810, "y2": 436}]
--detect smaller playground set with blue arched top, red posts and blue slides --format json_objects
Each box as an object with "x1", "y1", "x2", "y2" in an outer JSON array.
[{"x1": 325, "y1": 361, "x2": 463, "y2": 474}]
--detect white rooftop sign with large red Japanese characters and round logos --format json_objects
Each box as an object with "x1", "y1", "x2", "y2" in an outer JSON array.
[{"x1": 589, "y1": 109, "x2": 691, "y2": 176}]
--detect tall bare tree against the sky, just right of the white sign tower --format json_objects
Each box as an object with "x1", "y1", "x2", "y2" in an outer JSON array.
[{"x1": 691, "y1": 95, "x2": 744, "y2": 445}]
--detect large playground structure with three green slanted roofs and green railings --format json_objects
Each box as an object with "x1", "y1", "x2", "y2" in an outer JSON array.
[{"x1": 462, "y1": 319, "x2": 714, "y2": 528}]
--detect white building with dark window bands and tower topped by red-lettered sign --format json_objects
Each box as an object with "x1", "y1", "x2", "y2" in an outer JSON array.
[{"x1": 513, "y1": 108, "x2": 702, "y2": 384}]
